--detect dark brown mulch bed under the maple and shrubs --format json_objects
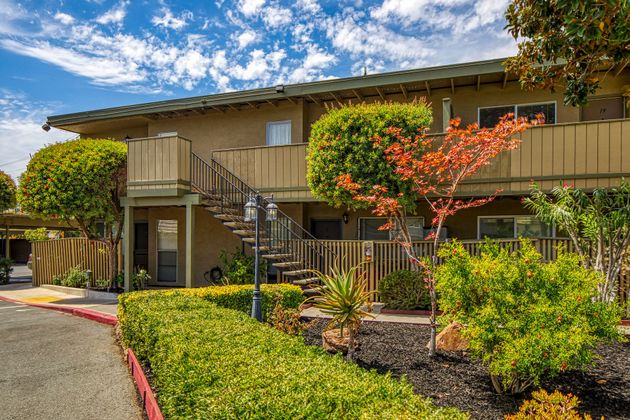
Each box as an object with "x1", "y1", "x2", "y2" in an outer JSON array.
[{"x1": 304, "y1": 320, "x2": 630, "y2": 419}]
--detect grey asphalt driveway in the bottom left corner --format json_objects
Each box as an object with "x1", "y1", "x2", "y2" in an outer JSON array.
[{"x1": 0, "y1": 301, "x2": 143, "y2": 420}]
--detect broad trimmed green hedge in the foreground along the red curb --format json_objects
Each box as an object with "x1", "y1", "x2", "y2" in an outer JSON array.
[{"x1": 119, "y1": 292, "x2": 466, "y2": 419}]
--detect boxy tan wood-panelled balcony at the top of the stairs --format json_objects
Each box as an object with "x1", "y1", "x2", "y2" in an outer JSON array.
[{"x1": 127, "y1": 136, "x2": 191, "y2": 197}]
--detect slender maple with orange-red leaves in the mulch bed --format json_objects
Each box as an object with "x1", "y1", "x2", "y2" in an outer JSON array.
[{"x1": 337, "y1": 114, "x2": 544, "y2": 356}]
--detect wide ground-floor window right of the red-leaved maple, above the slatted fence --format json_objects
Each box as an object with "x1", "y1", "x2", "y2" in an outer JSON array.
[{"x1": 477, "y1": 216, "x2": 553, "y2": 239}]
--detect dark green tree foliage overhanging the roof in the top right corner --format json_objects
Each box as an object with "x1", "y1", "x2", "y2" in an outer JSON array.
[{"x1": 505, "y1": 0, "x2": 630, "y2": 106}]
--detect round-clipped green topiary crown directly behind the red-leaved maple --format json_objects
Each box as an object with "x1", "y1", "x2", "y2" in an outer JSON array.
[{"x1": 306, "y1": 101, "x2": 432, "y2": 209}]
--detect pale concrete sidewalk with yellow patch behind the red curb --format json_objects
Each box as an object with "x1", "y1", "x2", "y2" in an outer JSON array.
[{"x1": 0, "y1": 283, "x2": 118, "y2": 315}]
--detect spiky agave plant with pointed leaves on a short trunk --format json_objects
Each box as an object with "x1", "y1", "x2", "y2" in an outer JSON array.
[{"x1": 309, "y1": 265, "x2": 373, "y2": 360}]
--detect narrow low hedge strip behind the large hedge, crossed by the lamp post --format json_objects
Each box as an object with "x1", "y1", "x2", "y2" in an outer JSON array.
[{"x1": 118, "y1": 284, "x2": 305, "y2": 320}]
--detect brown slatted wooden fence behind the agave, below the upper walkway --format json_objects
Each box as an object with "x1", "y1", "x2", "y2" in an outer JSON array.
[{"x1": 281, "y1": 238, "x2": 630, "y2": 302}]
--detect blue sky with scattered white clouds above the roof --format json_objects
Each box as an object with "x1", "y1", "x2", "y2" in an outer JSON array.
[{"x1": 0, "y1": 0, "x2": 516, "y2": 177}]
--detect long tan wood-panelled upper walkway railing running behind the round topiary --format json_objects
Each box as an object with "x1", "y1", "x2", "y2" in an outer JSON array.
[{"x1": 213, "y1": 119, "x2": 630, "y2": 201}]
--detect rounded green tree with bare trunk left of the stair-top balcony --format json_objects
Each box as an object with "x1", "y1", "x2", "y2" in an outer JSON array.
[{"x1": 18, "y1": 139, "x2": 127, "y2": 287}]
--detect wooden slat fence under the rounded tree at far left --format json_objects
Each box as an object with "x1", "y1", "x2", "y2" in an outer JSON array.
[{"x1": 31, "y1": 238, "x2": 122, "y2": 286}]
